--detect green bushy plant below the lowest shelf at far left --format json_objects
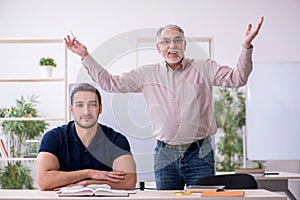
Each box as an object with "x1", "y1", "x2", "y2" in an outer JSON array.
[{"x1": 0, "y1": 161, "x2": 34, "y2": 189}]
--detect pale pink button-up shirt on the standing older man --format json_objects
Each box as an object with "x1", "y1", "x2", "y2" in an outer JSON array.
[{"x1": 82, "y1": 48, "x2": 253, "y2": 145}]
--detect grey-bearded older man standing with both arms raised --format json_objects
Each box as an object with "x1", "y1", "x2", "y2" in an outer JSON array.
[{"x1": 65, "y1": 18, "x2": 263, "y2": 190}]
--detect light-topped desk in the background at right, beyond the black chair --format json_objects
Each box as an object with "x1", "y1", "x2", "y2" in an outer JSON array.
[{"x1": 254, "y1": 172, "x2": 300, "y2": 200}]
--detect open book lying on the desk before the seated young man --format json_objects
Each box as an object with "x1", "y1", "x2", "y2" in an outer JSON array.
[{"x1": 57, "y1": 184, "x2": 135, "y2": 197}]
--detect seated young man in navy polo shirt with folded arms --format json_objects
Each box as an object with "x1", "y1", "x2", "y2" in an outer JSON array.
[{"x1": 36, "y1": 84, "x2": 136, "y2": 190}]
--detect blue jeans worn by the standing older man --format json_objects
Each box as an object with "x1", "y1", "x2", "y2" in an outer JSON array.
[{"x1": 154, "y1": 137, "x2": 215, "y2": 190}]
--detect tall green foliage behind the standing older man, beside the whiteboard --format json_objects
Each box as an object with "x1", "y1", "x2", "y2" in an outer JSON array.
[{"x1": 214, "y1": 89, "x2": 246, "y2": 171}]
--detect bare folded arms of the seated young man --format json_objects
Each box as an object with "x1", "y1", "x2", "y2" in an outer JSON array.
[{"x1": 36, "y1": 152, "x2": 136, "y2": 190}]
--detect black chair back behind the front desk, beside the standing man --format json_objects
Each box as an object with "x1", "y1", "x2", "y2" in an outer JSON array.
[{"x1": 196, "y1": 174, "x2": 258, "y2": 189}]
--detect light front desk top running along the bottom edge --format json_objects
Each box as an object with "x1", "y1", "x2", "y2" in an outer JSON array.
[{"x1": 0, "y1": 190, "x2": 287, "y2": 200}]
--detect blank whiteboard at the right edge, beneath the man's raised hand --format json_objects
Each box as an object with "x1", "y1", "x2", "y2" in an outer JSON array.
[{"x1": 246, "y1": 62, "x2": 300, "y2": 160}]
